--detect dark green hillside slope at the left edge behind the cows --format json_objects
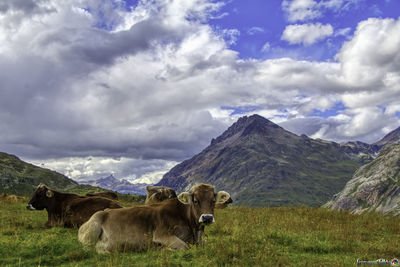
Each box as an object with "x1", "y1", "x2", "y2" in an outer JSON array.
[{"x1": 0, "y1": 152, "x2": 79, "y2": 196}]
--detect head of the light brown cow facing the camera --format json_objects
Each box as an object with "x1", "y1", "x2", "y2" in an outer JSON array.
[{"x1": 178, "y1": 184, "x2": 230, "y2": 224}]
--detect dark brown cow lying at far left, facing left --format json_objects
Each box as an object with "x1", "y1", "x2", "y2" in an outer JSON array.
[{"x1": 26, "y1": 183, "x2": 122, "y2": 228}]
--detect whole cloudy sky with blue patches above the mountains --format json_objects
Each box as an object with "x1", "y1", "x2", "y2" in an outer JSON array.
[{"x1": 0, "y1": 0, "x2": 400, "y2": 182}]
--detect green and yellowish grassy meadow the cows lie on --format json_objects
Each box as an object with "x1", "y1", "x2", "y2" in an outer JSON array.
[{"x1": 0, "y1": 198, "x2": 400, "y2": 266}]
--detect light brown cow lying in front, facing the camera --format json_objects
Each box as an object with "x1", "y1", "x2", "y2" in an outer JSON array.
[{"x1": 78, "y1": 184, "x2": 229, "y2": 253}]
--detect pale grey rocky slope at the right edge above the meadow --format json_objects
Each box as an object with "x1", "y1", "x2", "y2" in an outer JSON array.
[{"x1": 325, "y1": 144, "x2": 400, "y2": 215}]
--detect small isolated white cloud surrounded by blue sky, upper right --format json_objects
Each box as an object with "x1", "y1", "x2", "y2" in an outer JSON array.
[{"x1": 281, "y1": 23, "x2": 333, "y2": 45}]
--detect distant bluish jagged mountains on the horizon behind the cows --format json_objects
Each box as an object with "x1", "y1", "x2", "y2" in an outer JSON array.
[{"x1": 83, "y1": 174, "x2": 148, "y2": 195}]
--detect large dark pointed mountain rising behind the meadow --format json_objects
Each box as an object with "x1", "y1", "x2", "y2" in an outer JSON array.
[{"x1": 157, "y1": 115, "x2": 366, "y2": 206}]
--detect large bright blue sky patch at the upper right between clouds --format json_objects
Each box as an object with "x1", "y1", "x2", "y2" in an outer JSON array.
[{"x1": 210, "y1": 0, "x2": 400, "y2": 61}]
